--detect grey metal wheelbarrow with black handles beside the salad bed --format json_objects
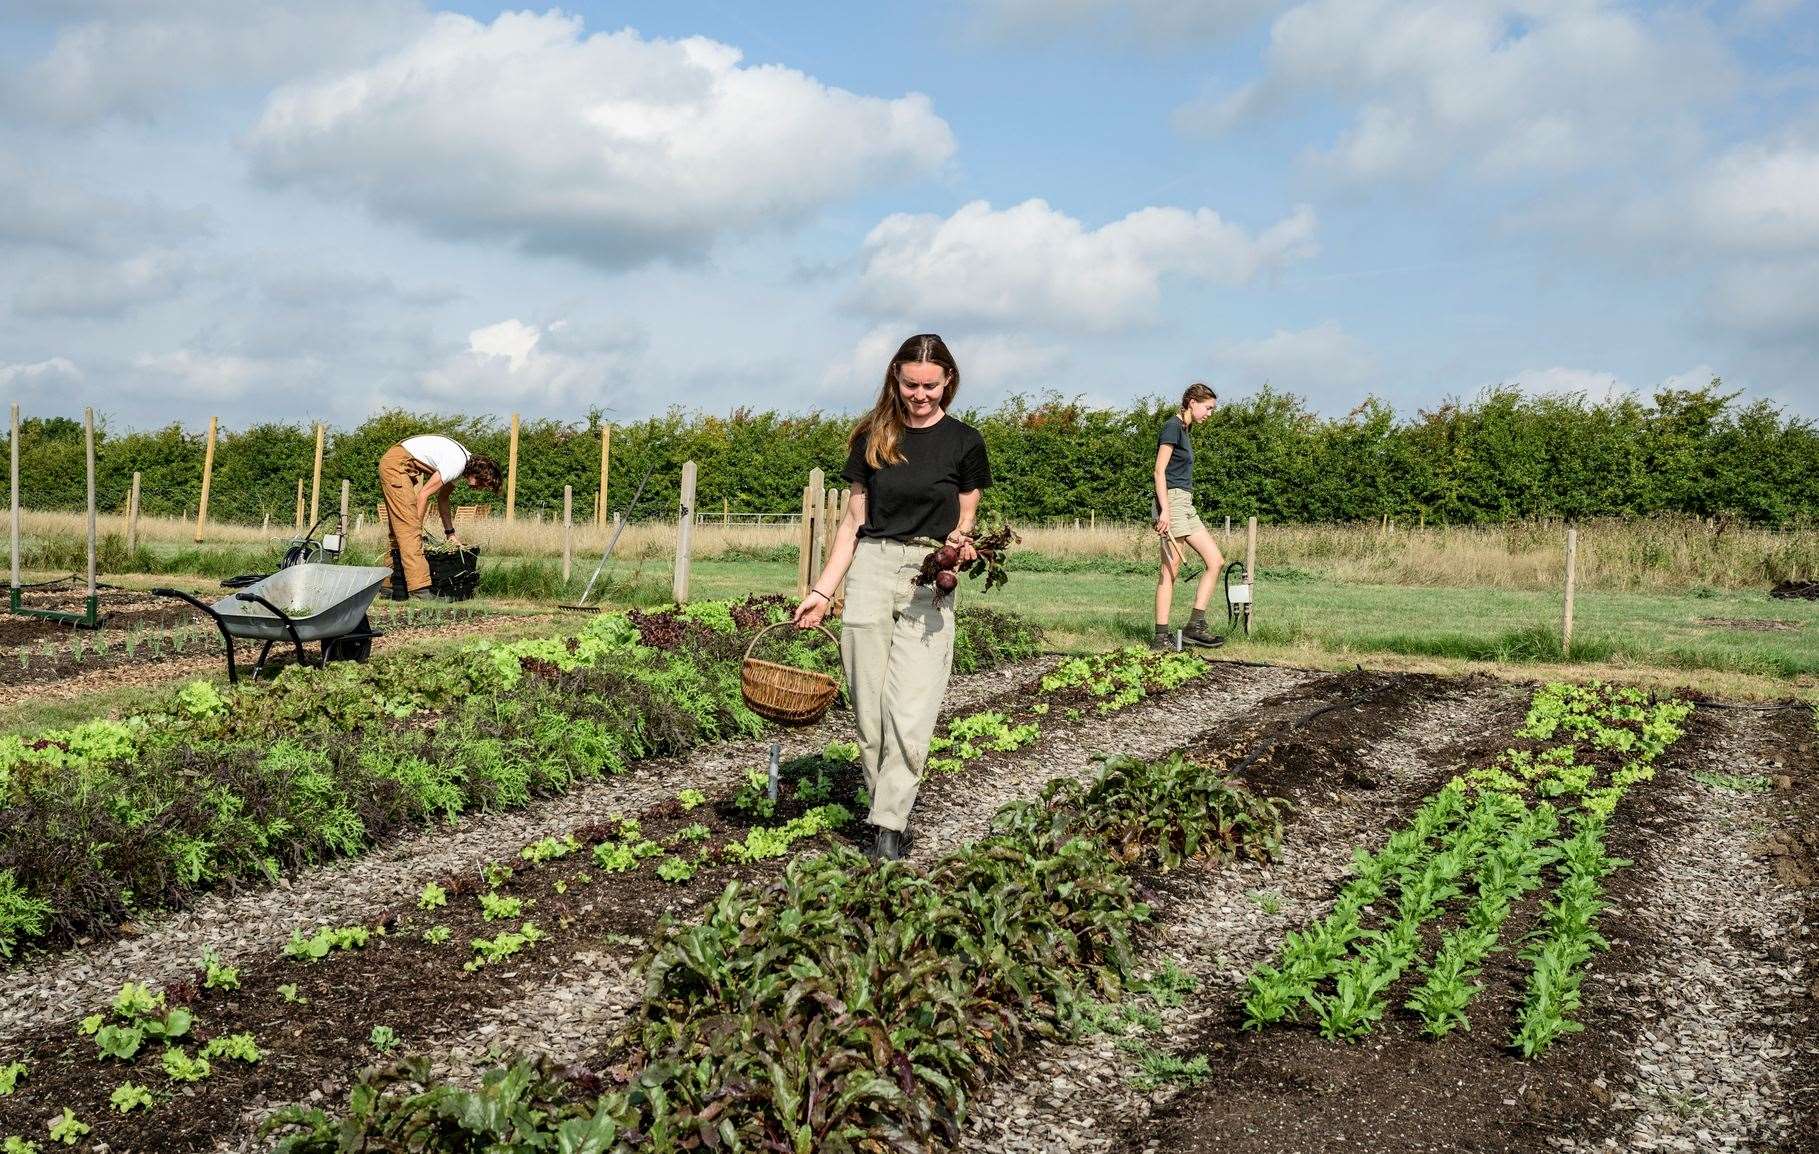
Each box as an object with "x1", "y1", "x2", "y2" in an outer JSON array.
[{"x1": 151, "y1": 562, "x2": 391, "y2": 681}]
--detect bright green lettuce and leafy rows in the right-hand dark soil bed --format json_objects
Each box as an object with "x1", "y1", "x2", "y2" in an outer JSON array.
[{"x1": 1244, "y1": 684, "x2": 1692, "y2": 1056}]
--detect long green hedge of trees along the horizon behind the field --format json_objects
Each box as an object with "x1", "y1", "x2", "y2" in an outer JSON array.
[{"x1": 0, "y1": 380, "x2": 1819, "y2": 526}]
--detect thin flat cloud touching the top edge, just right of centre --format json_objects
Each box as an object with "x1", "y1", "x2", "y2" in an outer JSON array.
[{"x1": 971, "y1": 0, "x2": 1282, "y2": 46}]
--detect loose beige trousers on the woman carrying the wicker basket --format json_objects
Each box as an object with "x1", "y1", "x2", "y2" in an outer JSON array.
[{"x1": 840, "y1": 539, "x2": 953, "y2": 830}]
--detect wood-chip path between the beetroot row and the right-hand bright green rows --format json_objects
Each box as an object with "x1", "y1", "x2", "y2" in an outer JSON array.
[{"x1": 962, "y1": 673, "x2": 1523, "y2": 1154}]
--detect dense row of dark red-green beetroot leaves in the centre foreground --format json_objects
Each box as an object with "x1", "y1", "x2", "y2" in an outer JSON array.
[{"x1": 263, "y1": 742, "x2": 1281, "y2": 1154}]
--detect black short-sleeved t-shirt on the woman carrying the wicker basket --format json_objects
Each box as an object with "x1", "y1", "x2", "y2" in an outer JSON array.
[{"x1": 840, "y1": 415, "x2": 991, "y2": 541}]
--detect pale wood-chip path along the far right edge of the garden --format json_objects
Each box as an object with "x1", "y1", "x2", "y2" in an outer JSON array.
[{"x1": 1553, "y1": 710, "x2": 1814, "y2": 1150}]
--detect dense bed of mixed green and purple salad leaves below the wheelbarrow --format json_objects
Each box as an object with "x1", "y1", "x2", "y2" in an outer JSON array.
[{"x1": 0, "y1": 599, "x2": 1040, "y2": 957}]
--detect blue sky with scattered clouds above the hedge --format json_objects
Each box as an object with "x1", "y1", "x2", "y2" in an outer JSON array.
[{"x1": 0, "y1": 0, "x2": 1819, "y2": 426}]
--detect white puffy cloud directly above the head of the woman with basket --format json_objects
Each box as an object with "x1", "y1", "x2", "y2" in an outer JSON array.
[{"x1": 859, "y1": 200, "x2": 1317, "y2": 331}]
